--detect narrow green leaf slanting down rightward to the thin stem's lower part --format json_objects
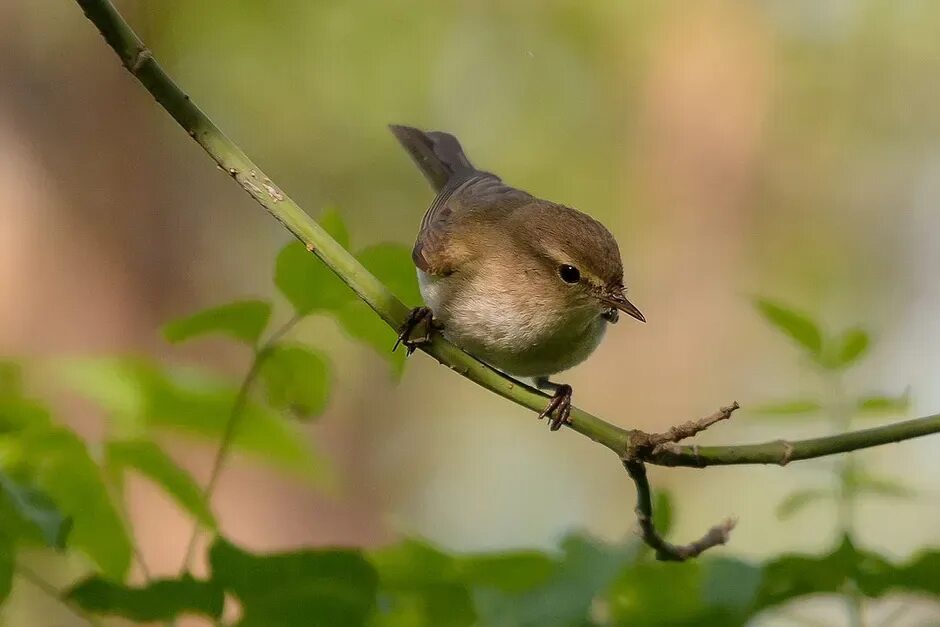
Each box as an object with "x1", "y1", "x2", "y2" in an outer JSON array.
[{"x1": 105, "y1": 440, "x2": 216, "y2": 529}]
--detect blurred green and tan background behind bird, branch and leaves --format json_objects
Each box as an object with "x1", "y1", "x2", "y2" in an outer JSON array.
[{"x1": 0, "y1": 0, "x2": 940, "y2": 624}]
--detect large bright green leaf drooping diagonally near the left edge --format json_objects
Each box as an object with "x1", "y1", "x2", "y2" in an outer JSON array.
[{"x1": 23, "y1": 427, "x2": 131, "y2": 581}]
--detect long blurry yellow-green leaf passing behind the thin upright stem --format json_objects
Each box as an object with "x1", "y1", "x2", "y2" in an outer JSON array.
[{"x1": 60, "y1": 358, "x2": 328, "y2": 480}]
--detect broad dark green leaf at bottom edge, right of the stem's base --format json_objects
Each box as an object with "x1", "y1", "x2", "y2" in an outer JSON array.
[{"x1": 209, "y1": 539, "x2": 378, "y2": 627}]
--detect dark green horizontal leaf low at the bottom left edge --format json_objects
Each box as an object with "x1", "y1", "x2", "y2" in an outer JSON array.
[{"x1": 67, "y1": 575, "x2": 225, "y2": 622}]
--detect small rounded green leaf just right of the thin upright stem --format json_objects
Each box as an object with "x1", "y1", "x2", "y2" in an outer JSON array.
[{"x1": 260, "y1": 345, "x2": 331, "y2": 418}]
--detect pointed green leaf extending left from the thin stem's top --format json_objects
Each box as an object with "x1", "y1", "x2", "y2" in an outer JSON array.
[{"x1": 163, "y1": 300, "x2": 271, "y2": 345}]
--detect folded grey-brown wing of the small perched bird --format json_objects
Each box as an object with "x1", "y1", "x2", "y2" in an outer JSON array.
[{"x1": 411, "y1": 171, "x2": 532, "y2": 275}]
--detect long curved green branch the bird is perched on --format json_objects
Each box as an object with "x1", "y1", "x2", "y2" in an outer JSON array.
[{"x1": 76, "y1": 0, "x2": 940, "y2": 466}]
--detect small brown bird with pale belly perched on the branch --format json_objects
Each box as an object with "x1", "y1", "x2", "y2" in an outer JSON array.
[{"x1": 389, "y1": 124, "x2": 646, "y2": 431}]
